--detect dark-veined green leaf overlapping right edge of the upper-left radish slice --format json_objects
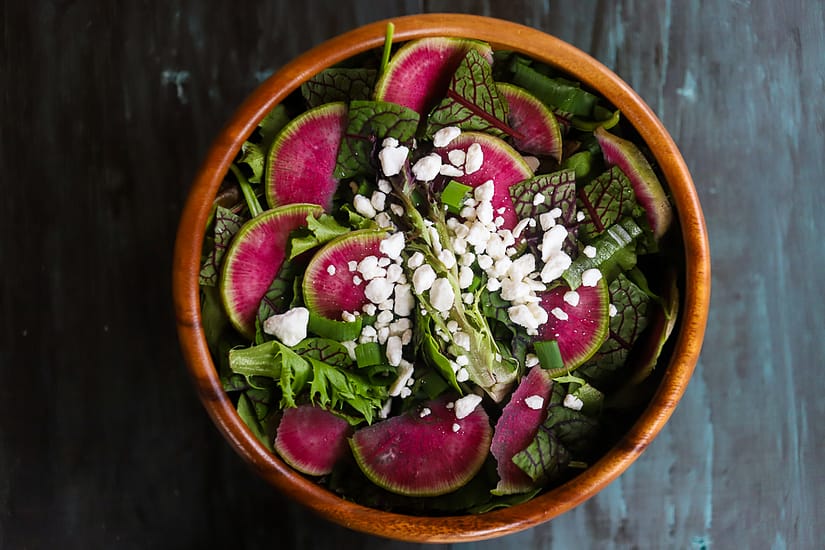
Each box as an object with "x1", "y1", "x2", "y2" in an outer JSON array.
[{"x1": 334, "y1": 100, "x2": 419, "y2": 179}]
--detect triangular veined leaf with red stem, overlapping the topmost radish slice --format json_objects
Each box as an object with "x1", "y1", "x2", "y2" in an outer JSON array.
[{"x1": 427, "y1": 49, "x2": 515, "y2": 137}]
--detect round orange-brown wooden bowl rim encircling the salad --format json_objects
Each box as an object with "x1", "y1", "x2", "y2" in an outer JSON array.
[{"x1": 173, "y1": 14, "x2": 710, "y2": 542}]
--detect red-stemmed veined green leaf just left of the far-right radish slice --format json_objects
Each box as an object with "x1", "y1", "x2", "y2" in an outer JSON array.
[{"x1": 579, "y1": 166, "x2": 641, "y2": 242}]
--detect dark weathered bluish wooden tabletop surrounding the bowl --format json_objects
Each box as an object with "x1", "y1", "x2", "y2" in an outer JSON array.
[{"x1": 0, "y1": 0, "x2": 825, "y2": 549}]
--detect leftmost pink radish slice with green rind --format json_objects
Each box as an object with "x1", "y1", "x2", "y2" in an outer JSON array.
[{"x1": 220, "y1": 204, "x2": 323, "y2": 339}]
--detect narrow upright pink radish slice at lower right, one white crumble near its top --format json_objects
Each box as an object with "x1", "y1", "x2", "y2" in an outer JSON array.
[{"x1": 490, "y1": 367, "x2": 553, "y2": 495}]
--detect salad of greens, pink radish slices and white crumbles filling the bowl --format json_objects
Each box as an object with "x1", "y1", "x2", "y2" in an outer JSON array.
[{"x1": 200, "y1": 27, "x2": 678, "y2": 514}]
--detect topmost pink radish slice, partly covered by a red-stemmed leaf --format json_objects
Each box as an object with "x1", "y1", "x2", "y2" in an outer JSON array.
[{"x1": 375, "y1": 37, "x2": 493, "y2": 115}]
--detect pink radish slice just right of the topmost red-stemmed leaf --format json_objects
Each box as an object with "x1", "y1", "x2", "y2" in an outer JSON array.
[{"x1": 496, "y1": 82, "x2": 562, "y2": 162}]
